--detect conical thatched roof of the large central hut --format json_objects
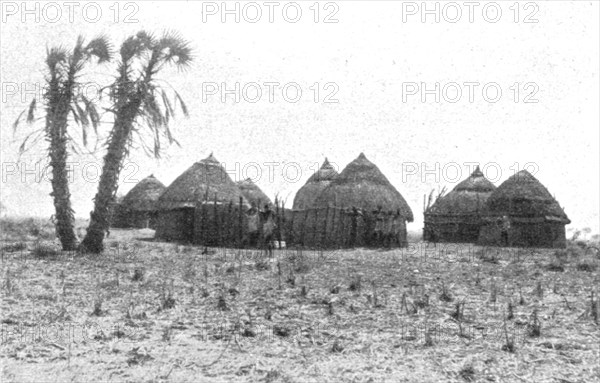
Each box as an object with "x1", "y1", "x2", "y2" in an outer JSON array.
[{"x1": 315, "y1": 153, "x2": 413, "y2": 222}]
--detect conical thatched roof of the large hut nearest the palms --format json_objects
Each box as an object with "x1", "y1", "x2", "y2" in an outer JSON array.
[{"x1": 159, "y1": 153, "x2": 249, "y2": 209}]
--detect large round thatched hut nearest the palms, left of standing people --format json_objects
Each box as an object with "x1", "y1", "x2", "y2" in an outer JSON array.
[{"x1": 156, "y1": 153, "x2": 250, "y2": 246}]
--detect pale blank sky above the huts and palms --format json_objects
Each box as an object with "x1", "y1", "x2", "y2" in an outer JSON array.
[{"x1": 0, "y1": 1, "x2": 600, "y2": 233}]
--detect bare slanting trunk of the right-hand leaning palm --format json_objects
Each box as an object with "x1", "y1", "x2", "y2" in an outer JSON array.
[{"x1": 81, "y1": 101, "x2": 140, "y2": 254}]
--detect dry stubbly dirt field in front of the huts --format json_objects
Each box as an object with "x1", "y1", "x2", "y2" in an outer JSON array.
[{"x1": 0, "y1": 222, "x2": 600, "y2": 383}]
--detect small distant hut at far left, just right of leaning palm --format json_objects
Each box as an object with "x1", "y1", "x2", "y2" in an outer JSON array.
[{"x1": 118, "y1": 175, "x2": 166, "y2": 229}]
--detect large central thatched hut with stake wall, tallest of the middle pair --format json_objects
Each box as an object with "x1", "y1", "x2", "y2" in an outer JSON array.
[{"x1": 290, "y1": 153, "x2": 413, "y2": 248}]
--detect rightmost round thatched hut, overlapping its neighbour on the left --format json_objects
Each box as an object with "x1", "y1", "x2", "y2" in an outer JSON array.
[{"x1": 478, "y1": 170, "x2": 571, "y2": 248}]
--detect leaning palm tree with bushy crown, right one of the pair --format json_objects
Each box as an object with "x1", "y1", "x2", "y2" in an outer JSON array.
[{"x1": 81, "y1": 31, "x2": 192, "y2": 253}]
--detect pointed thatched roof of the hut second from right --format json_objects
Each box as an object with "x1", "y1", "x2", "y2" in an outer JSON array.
[{"x1": 425, "y1": 166, "x2": 496, "y2": 216}]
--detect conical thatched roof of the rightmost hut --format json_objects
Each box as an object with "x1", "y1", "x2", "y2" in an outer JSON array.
[{"x1": 487, "y1": 170, "x2": 571, "y2": 223}]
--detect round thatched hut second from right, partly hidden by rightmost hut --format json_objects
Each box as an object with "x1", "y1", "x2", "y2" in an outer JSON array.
[{"x1": 423, "y1": 166, "x2": 496, "y2": 243}]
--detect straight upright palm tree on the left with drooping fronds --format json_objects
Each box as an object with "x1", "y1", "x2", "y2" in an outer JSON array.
[{"x1": 13, "y1": 36, "x2": 111, "y2": 250}]
